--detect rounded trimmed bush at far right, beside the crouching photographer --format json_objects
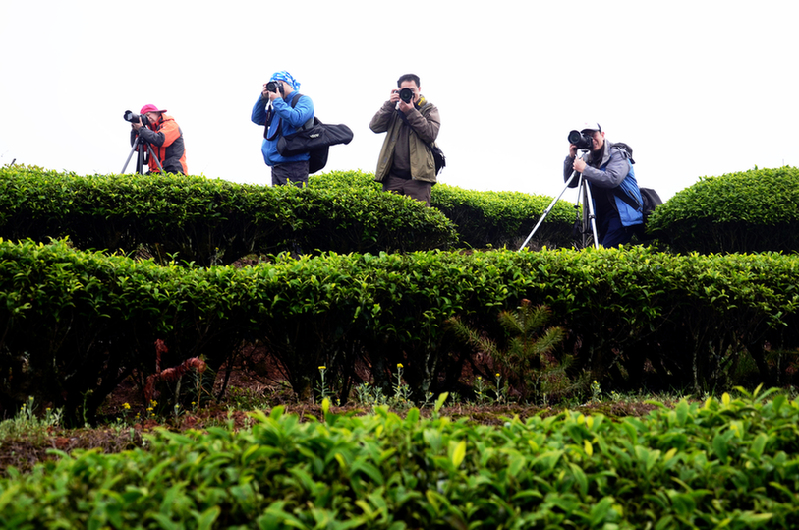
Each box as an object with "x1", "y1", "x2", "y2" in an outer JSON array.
[{"x1": 648, "y1": 166, "x2": 799, "y2": 254}]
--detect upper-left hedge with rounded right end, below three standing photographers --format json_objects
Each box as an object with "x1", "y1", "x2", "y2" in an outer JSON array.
[{"x1": 0, "y1": 166, "x2": 458, "y2": 265}]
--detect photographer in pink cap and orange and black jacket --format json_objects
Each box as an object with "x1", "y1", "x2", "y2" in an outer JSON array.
[{"x1": 130, "y1": 104, "x2": 188, "y2": 175}]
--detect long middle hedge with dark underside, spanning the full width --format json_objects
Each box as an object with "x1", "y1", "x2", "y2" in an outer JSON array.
[{"x1": 0, "y1": 241, "x2": 799, "y2": 416}]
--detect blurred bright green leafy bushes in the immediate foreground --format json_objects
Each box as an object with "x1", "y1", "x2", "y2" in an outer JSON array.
[{"x1": 0, "y1": 386, "x2": 799, "y2": 530}]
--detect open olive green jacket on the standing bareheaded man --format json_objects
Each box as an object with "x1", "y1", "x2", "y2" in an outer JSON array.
[{"x1": 369, "y1": 96, "x2": 441, "y2": 183}]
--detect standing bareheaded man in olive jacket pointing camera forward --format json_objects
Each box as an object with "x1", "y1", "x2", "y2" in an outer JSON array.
[{"x1": 369, "y1": 74, "x2": 441, "y2": 206}]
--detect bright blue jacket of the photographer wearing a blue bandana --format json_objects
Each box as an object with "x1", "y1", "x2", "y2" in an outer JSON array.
[{"x1": 252, "y1": 92, "x2": 313, "y2": 166}]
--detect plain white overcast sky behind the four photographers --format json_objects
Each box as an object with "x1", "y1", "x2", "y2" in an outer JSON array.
[{"x1": 0, "y1": 0, "x2": 799, "y2": 202}]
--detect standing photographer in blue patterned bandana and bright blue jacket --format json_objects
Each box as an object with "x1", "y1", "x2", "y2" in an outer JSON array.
[{"x1": 252, "y1": 70, "x2": 314, "y2": 187}]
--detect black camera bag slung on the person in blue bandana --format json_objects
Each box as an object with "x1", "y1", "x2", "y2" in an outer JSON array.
[{"x1": 264, "y1": 93, "x2": 353, "y2": 173}]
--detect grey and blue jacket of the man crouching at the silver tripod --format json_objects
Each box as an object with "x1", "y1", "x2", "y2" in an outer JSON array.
[{"x1": 563, "y1": 140, "x2": 644, "y2": 226}]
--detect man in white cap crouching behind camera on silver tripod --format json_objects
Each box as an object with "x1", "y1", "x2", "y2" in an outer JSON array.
[{"x1": 563, "y1": 123, "x2": 644, "y2": 248}]
